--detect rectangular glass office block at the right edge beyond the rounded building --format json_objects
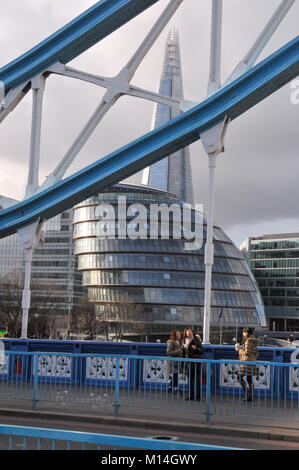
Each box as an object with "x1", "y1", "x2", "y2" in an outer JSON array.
[{"x1": 249, "y1": 233, "x2": 299, "y2": 331}]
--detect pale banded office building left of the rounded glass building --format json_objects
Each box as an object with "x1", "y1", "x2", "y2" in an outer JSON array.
[{"x1": 0, "y1": 210, "x2": 84, "y2": 330}]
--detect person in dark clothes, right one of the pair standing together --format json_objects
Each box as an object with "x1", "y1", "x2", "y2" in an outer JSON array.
[{"x1": 183, "y1": 328, "x2": 204, "y2": 400}]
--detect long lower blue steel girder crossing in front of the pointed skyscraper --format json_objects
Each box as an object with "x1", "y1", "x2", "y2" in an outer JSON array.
[{"x1": 0, "y1": 34, "x2": 299, "y2": 237}]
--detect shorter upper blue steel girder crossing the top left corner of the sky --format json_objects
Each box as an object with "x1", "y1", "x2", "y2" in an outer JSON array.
[{"x1": 0, "y1": 0, "x2": 159, "y2": 94}]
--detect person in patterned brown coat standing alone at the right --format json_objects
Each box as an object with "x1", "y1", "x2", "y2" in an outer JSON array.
[{"x1": 235, "y1": 328, "x2": 258, "y2": 401}]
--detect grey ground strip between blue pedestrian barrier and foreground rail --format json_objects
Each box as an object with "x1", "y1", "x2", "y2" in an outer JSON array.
[{"x1": 0, "y1": 392, "x2": 299, "y2": 443}]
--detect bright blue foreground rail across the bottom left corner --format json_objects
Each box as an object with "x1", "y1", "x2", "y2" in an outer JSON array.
[{"x1": 0, "y1": 424, "x2": 243, "y2": 452}]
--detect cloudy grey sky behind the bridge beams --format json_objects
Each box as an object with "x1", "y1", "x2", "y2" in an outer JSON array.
[{"x1": 0, "y1": 0, "x2": 299, "y2": 245}]
